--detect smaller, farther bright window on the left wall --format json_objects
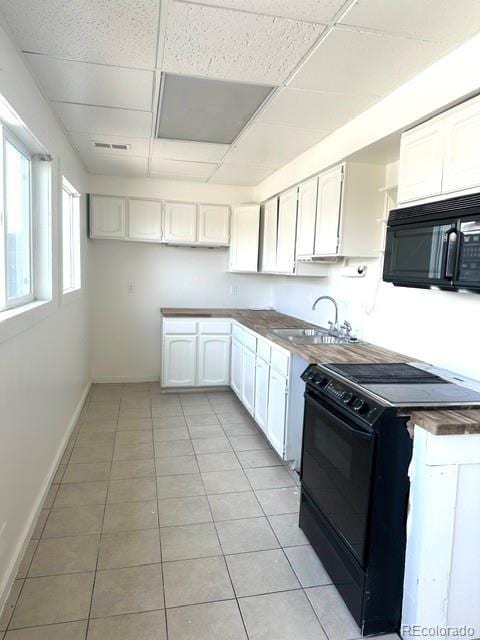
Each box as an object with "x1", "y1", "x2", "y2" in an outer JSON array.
[{"x1": 62, "y1": 178, "x2": 81, "y2": 293}]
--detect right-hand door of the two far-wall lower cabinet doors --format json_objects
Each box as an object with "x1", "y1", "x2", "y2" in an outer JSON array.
[{"x1": 198, "y1": 335, "x2": 230, "y2": 386}]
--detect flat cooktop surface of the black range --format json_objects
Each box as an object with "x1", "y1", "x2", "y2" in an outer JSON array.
[{"x1": 318, "y1": 363, "x2": 480, "y2": 408}]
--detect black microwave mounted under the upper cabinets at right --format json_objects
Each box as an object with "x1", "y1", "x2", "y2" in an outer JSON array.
[{"x1": 383, "y1": 193, "x2": 480, "y2": 293}]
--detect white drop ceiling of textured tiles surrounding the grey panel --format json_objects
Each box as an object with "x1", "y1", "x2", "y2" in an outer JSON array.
[{"x1": 0, "y1": 0, "x2": 480, "y2": 185}]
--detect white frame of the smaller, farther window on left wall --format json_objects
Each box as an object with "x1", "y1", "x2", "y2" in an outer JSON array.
[{"x1": 60, "y1": 175, "x2": 82, "y2": 297}]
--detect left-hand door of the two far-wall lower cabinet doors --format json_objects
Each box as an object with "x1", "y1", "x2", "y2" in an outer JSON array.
[{"x1": 162, "y1": 335, "x2": 197, "y2": 387}]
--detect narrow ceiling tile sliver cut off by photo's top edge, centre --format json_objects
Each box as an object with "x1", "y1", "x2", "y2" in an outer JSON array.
[{"x1": 183, "y1": 0, "x2": 345, "y2": 23}]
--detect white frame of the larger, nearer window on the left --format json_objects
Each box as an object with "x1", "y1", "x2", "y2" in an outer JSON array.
[{"x1": 0, "y1": 121, "x2": 36, "y2": 313}]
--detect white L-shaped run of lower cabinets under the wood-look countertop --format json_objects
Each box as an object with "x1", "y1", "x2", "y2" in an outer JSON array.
[{"x1": 161, "y1": 317, "x2": 307, "y2": 469}]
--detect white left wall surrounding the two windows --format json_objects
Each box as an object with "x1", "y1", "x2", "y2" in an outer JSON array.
[{"x1": 0, "y1": 22, "x2": 90, "y2": 610}]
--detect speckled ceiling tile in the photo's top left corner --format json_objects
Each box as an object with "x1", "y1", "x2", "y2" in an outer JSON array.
[{"x1": 0, "y1": 0, "x2": 160, "y2": 68}]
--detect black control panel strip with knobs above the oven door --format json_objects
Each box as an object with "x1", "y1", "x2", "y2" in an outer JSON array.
[{"x1": 302, "y1": 365, "x2": 384, "y2": 424}]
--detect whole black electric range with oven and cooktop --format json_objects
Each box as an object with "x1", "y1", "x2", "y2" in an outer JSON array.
[{"x1": 299, "y1": 363, "x2": 480, "y2": 635}]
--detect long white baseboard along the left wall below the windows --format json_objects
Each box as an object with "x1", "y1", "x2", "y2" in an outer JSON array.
[{"x1": 0, "y1": 382, "x2": 92, "y2": 615}]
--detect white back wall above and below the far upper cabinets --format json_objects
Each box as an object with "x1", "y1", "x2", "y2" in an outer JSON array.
[{"x1": 89, "y1": 176, "x2": 272, "y2": 380}]
